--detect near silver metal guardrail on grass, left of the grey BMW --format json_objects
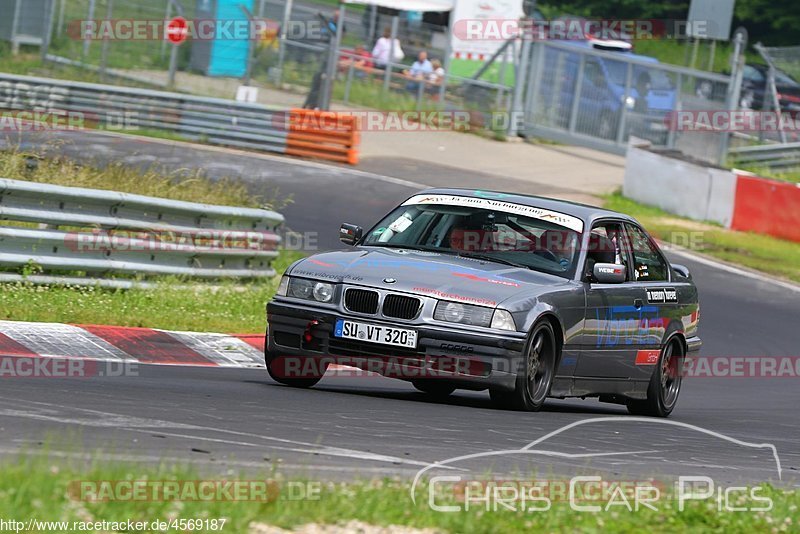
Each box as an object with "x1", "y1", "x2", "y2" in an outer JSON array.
[{"x1": 0, "y1": 179, "x2": 284, "y2": 287}]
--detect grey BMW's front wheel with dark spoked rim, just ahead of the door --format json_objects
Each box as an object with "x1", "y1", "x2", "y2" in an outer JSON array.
[{"x1": 489, "y1": 321, "x2": 558, "y2": 412}]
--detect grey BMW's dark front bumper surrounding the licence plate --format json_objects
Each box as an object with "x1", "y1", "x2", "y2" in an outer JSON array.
[{"x1": 266, "y1": 300, "x2": 525, "y2": 390}]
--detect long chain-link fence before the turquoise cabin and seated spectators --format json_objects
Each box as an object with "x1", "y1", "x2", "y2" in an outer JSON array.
[{"x1": 29, "y1": 0, "x2": 514, "y2": 125}]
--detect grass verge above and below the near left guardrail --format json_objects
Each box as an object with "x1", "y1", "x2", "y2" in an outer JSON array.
[{"x1": 0, "y1": 150, "x2": 301, "y2": 333}]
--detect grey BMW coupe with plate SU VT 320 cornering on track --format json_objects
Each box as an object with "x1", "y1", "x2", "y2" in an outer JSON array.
[{"x1": 265, "y1": 189, "x2": 701, "y2": 417}]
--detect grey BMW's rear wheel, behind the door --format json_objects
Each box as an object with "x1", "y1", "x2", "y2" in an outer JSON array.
[{"x1": 627, "y1": 338, "x2": 685, "y2": 417}]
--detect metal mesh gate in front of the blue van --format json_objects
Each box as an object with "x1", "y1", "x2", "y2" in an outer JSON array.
[{"x1": 524, "y1": 42, "x2": 729, "y2": 161}]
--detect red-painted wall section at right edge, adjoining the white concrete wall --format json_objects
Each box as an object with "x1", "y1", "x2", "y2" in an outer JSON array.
[{"x1": 731, "y1": 174, "x2": 800, "y2": 242}]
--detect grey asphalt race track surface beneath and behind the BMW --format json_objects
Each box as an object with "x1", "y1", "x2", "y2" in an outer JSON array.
[{"x1": 0, "y1": 133, "x2": 800, "y2": 487}]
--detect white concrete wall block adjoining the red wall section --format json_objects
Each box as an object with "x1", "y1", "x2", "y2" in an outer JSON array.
[{"x1": 623, "y1": 138, "x2": 736, "y2": 227}]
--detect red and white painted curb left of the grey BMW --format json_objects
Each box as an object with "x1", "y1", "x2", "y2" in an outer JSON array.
[{"x1": 0, "y1": 321, "x2": 264, "y2": 368}]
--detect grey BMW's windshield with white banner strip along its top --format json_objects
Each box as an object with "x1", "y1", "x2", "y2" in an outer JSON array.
[{"x1": 361, "y1": 196, "x2": 582, "y2": 278}]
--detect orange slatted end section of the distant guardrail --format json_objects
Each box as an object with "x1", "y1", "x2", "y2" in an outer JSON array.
[{"x1": 286, "y1": 109, "x2": 360, "y2": 165}]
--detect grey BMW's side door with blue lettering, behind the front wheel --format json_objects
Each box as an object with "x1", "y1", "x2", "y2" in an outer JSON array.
[{"x1": 575, "y1": 221, "x2": 657, "y2": 378}]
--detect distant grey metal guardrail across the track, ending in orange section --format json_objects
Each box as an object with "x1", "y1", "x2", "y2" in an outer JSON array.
[{"x1": 0, "y1": 73, "x2": 358, "y2": 165}]
